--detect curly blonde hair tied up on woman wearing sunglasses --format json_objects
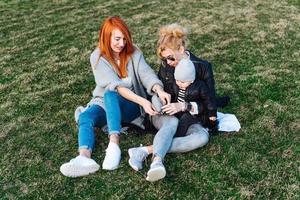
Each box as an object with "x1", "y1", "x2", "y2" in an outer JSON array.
[{"x1": 157, "y1": 23, "x2": 187, "y2": 57}]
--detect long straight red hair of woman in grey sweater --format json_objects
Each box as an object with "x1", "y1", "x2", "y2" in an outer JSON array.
[{"x1": 98, "y1": 16, "x2": 134, "y2": 78}]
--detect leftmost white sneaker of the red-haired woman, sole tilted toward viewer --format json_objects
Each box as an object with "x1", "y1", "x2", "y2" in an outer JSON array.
[{"x1": 60, "y1": 155, "x2": 100, "y2": 177}]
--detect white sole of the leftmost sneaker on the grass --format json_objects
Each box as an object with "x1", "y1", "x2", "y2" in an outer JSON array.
[{"x1": 60, "y1": 164, "x2": 100, "y2": 177}]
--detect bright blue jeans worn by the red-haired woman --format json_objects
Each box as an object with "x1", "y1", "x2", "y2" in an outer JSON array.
[{"x1": 78, "y1": 91, "x2": 141, "y2": 151}]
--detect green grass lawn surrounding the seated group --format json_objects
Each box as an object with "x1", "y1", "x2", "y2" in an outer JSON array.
[{"x1": 0, "y1": 0, "x2": 300, "y2": 199}]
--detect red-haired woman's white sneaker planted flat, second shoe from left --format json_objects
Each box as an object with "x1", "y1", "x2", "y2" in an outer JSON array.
[{"x1": 102, "y1": 142, "x2": 121, "y2": 170}]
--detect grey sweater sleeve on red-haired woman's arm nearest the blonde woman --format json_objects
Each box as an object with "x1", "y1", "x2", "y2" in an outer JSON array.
[{"x1": 137, "y1": 54, "x2": 163, "y2": 95}]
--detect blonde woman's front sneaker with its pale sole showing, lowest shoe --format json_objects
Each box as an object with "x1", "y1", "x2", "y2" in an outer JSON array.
[{"x1": 146, "y1": 160, "x2": 166, "y2": 182}]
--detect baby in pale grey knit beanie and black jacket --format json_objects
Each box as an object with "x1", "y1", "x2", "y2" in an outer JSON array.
[{"x1": 152, "y1": 59, "x2": 217, "y2": 137}]
